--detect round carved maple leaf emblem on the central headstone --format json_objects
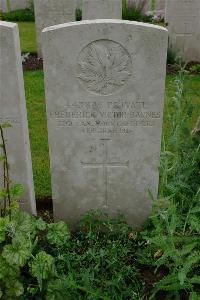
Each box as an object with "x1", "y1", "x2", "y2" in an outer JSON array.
[{"x1": 77, "y1": 40, "x2": 132, "y2": 95}]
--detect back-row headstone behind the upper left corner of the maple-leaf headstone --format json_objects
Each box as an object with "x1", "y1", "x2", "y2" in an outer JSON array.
[{"x1": 34, "y1": 0, "x2": 76, "y2": 57}]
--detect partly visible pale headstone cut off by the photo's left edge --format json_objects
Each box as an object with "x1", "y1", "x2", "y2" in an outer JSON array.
[{"x1": 0, "y1": 21, "x2": 36, "y2": 214}]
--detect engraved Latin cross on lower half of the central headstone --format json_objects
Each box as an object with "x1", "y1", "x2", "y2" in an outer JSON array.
[{"x1": 81, "y1": 139, "x2": 129, "y2": 207}]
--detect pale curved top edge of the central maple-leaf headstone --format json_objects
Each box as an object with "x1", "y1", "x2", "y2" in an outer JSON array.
[{"x1": 42, "y1": 19, "x2": 168, "y2": 33}]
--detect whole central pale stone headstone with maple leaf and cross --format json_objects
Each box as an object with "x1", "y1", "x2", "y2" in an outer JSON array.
[{"x1": 43, "y1": 20, "x2": 168, "y2": 226}]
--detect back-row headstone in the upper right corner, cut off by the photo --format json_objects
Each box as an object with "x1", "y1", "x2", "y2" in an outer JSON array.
[{"x1": 166, "y1": 0, "x2": 200, "y2": 62}]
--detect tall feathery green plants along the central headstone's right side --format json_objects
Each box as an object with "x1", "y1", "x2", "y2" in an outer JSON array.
[{"x1": 139, "y1": 68, "x2": 200, "y2": 299}]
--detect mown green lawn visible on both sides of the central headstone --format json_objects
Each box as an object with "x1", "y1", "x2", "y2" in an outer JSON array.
[{"x1": 24, "y1": 71, "x2": 200, "y2": 199}]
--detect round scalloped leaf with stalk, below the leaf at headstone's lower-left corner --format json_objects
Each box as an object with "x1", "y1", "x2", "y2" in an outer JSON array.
[{"x1": 29, "y1": 251, "x2": 56, "y2": 290}]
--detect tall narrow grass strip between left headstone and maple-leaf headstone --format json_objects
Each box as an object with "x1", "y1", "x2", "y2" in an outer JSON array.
[{"x1": 24, "y1": 71, "x2": 51, "y2": 198}]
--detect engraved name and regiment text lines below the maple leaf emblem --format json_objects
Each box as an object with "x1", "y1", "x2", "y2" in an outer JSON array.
[{"x1": 49, "y1": 102, "x2": 162, "y2": 135}]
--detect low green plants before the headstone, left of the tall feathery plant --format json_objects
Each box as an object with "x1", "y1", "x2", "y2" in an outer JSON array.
[{"x1": 0, "y1": 207, "x2": 142, "y2": 299}]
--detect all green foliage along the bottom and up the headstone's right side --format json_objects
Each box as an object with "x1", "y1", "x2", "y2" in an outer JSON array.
[{"x1": 0, "y1": 69, "x2": 200, "y2": 300}]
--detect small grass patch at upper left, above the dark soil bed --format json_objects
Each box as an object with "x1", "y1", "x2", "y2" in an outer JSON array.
[{"x1": 18, "y1": 22, "x2": 37, "y2": 53}]
